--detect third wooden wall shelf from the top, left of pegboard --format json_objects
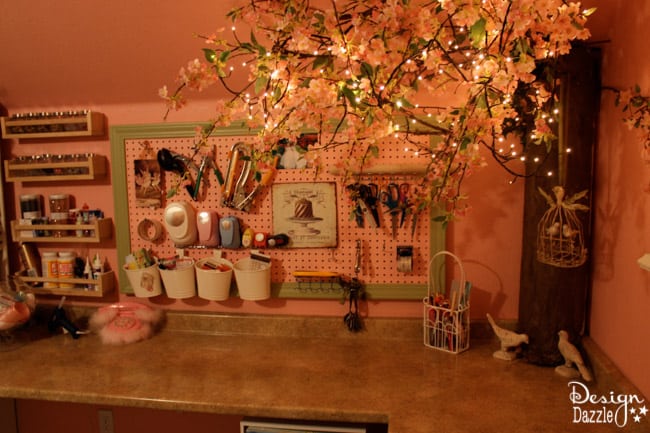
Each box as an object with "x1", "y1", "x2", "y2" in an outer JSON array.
[{"x1": 11, "y1": 218, "x2": 113, "y2": 243}]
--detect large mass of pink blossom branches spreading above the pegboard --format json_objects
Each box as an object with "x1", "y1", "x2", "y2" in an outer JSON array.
[{"x1": 160, "y1": 0, "x2": 591, "y2": 214}]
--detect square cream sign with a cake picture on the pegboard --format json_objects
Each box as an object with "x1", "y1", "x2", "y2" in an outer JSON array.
[{"x1": 272, "y1": 182, "x2": 337, "y2": 248}]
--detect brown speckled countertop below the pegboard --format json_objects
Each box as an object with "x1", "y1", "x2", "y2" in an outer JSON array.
[{"x1": 0, "y1": 313, "x2": 650, "y2": 433}]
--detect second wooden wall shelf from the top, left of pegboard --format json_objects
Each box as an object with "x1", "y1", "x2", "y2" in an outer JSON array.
[{"x1": 5, "y1": 155, "x2": 106, "y2": 182}]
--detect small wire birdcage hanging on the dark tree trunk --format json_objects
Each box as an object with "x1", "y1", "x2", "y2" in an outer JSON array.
[{"x1": 537, "y1": 186, "x2": 589, "y2": 268}]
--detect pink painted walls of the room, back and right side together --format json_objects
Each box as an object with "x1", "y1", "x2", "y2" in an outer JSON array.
[{"x1": 0, "y1": 0, "x2": 650, "y2": 395}]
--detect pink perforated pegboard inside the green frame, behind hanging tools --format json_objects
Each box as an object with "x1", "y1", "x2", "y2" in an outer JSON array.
[{"x1": 125, "y1": 136, "x2": 429, "y2": 284}]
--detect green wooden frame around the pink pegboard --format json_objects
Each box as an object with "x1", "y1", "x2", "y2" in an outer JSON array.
[{"x1": 110, "y1": 122, "x2": 445, "y2": 300}]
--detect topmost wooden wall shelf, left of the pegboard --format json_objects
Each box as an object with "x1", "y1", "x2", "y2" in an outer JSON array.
[{"x1": 0, "y1": 111, "x2": 104, "y2": 139}]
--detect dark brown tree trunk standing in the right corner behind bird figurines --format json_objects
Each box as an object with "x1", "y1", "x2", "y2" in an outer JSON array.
[{"x1": 519, "y1": 46, "x2": 600, "y2": 365}]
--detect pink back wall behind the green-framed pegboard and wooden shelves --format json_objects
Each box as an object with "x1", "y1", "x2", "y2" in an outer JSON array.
[{"x1": 0, "y1": 0, "x2": 523, "y2": 319}]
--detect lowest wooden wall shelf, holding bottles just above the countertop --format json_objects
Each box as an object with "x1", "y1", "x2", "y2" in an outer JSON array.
[{"x1": 16, "y1": 271, "x2": 115, "y2": 298}]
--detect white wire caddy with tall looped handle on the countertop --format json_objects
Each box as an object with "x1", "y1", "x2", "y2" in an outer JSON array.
[{"x1": 423, "y1": 251, "x2": 471, "y2": 354}]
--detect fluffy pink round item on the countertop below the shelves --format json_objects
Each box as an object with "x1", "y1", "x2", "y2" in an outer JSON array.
[{"x1": 89, "y1": 302, "x2": 163, "y2": 344}]
